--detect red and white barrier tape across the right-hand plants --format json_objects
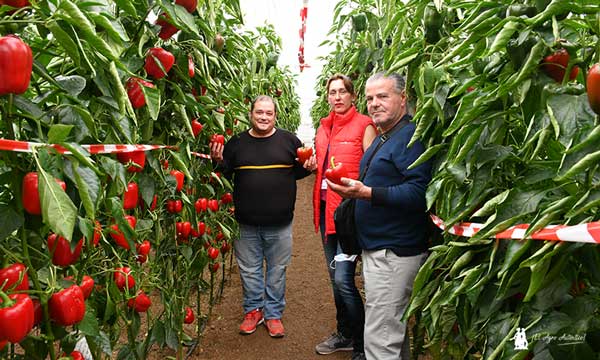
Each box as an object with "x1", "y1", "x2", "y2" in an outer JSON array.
[{"x1": 431, "y1": 215, "x2": 600, "y2": 244}]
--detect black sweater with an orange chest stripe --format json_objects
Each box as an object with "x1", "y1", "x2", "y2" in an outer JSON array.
[{"x1": 222, "y1": 129, "x2": 310, "y2": 226}]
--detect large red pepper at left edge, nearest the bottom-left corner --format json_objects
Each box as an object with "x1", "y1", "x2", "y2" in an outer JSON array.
[{"x1": 0, "y1": 293, "x2": 34, "y2": 344}]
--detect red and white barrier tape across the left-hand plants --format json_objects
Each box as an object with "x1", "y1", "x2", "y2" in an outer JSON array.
[{"x1": 0, "y1": 139, "x2": 210, "y2": 159}]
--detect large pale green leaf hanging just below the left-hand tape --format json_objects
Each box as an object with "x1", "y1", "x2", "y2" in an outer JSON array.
[{"x1": 38, "y1": 164, "x2": 77, "y2": 241}]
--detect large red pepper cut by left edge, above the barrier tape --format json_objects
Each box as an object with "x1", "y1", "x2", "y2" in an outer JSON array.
[{"x1": 0, "y1": 35, "x2": 33, "y2": 96}]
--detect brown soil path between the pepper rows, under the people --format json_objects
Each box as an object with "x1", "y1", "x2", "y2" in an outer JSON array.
[{"x1": 190, "y1": 176, "x2": 358, "y2": 360}]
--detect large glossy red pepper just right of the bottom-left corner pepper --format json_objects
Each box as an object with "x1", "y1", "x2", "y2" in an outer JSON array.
[{"x1": 48, "y1": 285, "x2": 85, "y2": 326}]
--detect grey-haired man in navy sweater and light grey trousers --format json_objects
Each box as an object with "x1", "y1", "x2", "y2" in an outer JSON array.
[{"x1": 328, "y1": 73, "x2": 431, "y2": 360}]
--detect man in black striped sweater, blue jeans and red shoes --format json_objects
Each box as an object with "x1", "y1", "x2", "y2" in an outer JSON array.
[{"x1": 211, "y1": 95, "x2": 311, "y2": 337}]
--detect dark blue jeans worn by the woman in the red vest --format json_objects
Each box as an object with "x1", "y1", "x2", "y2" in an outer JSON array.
[{"x1": 320, "y1": 201, "x2": 365, "y2": 352}]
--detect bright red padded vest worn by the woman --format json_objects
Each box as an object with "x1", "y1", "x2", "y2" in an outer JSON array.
[{"x1": 313, "y1": 106, "x2": 373, "y2": 235}]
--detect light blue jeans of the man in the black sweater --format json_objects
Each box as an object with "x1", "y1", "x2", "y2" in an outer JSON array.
[{"x1": 234, "y1": 222, "x2": 292, "y2": 319}]
